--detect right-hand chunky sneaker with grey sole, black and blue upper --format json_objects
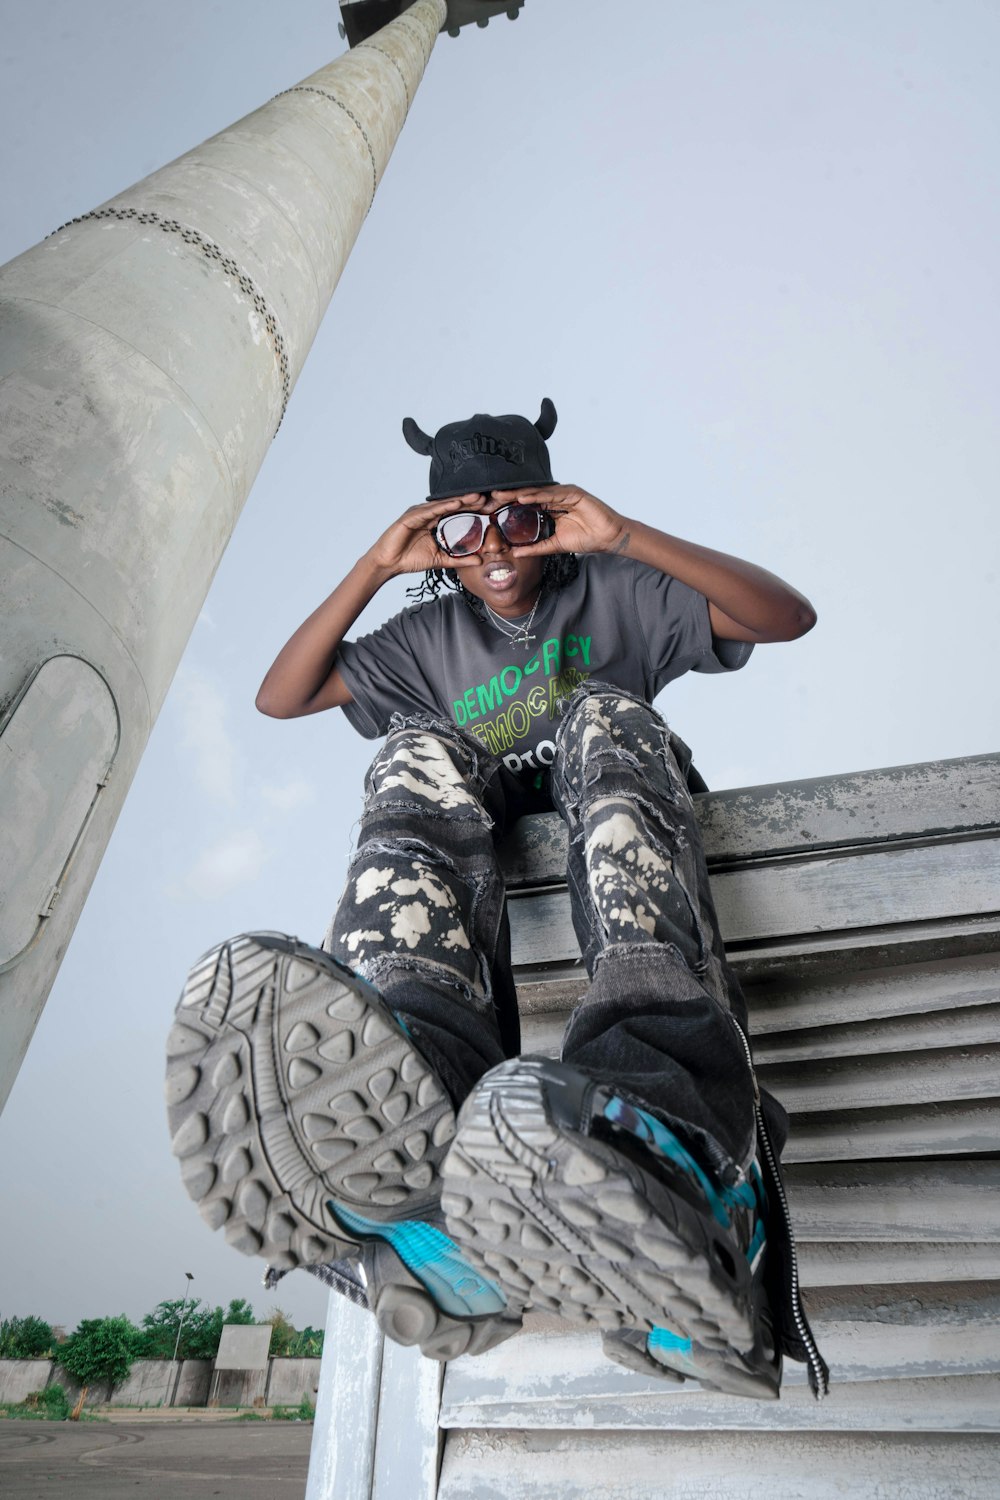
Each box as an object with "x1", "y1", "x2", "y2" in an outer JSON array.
[{"x1": 441, "y1": 1058, "x2": 763, "y2": 1368}]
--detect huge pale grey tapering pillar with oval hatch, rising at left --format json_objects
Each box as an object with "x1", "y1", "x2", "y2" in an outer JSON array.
[{"x1": 0, "y1": 0, "x2": 447, "y2": 1106}]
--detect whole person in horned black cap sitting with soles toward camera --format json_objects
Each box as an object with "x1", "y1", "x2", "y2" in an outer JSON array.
[{"x1": 168, "y1": 401, "x2": 826, "y2": 1395}]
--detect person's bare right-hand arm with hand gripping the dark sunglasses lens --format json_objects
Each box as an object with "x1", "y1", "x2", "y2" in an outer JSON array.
[{"x1": 495, "y1": 485, "x2": 816, "y2": 641}]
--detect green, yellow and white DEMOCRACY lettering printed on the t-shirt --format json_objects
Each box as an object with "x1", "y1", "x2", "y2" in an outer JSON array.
[{"x1": 451, "y1": 635, "x2": 591, "y2": 774}]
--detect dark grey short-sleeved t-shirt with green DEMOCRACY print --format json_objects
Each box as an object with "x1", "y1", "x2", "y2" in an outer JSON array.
[{"x1": 337, "y1": 554, "x2": 753, "y2": 780}]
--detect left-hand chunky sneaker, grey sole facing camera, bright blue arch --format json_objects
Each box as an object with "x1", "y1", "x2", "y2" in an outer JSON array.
[{"x1": 166, "y1": 933, "x2": 520, "y2": 1359}]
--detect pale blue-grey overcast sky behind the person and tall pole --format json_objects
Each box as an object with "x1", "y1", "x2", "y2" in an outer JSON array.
[{"x1": 0, "y1": 0, "x2": 1000, "y2": 1326}]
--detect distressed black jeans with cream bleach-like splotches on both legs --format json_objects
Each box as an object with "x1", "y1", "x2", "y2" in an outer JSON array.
[{"x1": 325, "y1": 681, "x2": 767, "y2": 1178}]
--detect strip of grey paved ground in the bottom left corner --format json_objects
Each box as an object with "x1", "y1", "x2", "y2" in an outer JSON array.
[{"x1": 0, "y1": 1419, "x2": 312, "y2": 1500}]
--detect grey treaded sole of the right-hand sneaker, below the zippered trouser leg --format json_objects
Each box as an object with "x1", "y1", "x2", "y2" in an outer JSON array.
[{"x1": 441, "y1": 1061, "x2": 754, "y2": 1350}]
